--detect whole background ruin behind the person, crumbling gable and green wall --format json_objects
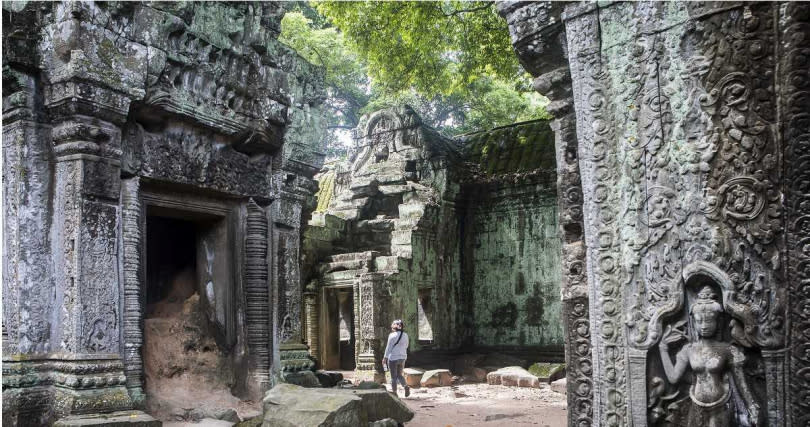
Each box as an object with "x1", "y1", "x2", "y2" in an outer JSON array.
[{"x1": 303, "y1": 108, "x2": 563, "y2": 379}]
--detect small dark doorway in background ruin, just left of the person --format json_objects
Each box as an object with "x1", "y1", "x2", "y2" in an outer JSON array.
[{"x1": 321, "y1": 286, "x2": 356, "y2": 371}]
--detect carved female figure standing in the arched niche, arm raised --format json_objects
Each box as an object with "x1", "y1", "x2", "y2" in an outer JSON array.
[{"x1": 659, "y1": 285, "x2": 760, "y2": 427}]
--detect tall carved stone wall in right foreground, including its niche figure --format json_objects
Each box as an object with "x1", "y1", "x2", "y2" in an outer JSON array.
[{"x1": 498, "y1": 2, "x2": 810, "y2": 427}]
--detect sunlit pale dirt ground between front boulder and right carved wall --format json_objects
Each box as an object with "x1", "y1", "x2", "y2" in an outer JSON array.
[{"x1": 400, "y1": 384, "x2": 567, "y2": 427}]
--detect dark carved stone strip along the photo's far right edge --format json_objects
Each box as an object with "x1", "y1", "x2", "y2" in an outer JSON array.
[{"x1": 780, "y1": 2, "x2": 810, "y2": 425}]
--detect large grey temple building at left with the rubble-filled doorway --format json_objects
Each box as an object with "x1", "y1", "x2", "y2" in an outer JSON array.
[{"x1": 2, "y1": 2, "x2": 325, "y2": 425}]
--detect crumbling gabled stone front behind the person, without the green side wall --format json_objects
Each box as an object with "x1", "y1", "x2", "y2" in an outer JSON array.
[{"x1": 303, "y1": 107, "x2": 466, "y2": 378}]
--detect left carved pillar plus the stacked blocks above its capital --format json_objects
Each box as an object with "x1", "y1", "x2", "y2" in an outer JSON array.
[{"x1": 43, "y1": 2, "x2": 146, "y2": 416}]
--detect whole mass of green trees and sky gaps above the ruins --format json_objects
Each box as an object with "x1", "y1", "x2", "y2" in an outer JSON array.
[{"x1": 281, "y1": 1, "x2": 547, "y2": 158}]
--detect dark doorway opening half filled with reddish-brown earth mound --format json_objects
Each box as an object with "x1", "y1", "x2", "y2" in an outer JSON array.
[{"x1": 141, "y1": 199, "x2": 253, "y2": 421}]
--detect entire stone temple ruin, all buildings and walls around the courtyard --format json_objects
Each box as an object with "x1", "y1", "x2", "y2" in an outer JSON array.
[{"x1": 2, "y1": 1, "x2": 810, "y2": 427}]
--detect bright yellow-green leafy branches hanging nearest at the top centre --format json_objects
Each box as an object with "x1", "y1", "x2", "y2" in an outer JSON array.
[{"x1": 315, "y1": 1, "x2": 520, "y2": 95}]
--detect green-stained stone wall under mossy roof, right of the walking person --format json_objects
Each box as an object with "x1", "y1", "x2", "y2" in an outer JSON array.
[{"x1": 459, "y1": 120, "x2": 562, "y2": 357}]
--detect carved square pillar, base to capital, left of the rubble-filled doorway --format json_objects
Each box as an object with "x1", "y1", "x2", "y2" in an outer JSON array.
[{"x1": 45, "y1": 72, "x2": 137, "y2": 414}]
